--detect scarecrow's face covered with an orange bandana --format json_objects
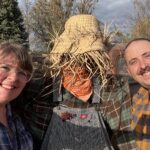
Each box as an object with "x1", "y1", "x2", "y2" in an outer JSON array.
[{"x1": 62, "y1": 67, "x2": 92, "y2": 102}]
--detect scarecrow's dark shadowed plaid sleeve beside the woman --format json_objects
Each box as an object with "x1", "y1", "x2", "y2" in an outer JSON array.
[{"x1": 12, "y1": 78, "x2": 57, "y2": 150}]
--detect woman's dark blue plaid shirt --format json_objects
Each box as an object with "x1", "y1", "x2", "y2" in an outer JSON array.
[{"x1": 0, "y1": 105, "x2": 33, "y2": 150}]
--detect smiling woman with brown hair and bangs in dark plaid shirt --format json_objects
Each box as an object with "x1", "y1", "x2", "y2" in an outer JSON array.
[{"x1": 0, "y1": 42, "x2": 33, "y2": 150}]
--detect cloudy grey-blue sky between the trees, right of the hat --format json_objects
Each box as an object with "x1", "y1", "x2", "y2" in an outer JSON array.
[{"x1": 18, "y1": 0, "x2": 133, "y2": 32}]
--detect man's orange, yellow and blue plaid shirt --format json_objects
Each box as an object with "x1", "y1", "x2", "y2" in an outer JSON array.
[{"x1": 131, "y1": 87, "x2": 150, "y2": 150}]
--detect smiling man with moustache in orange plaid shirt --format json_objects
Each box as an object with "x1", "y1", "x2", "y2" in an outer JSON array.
[{"x1": 124, "y1": 38, "x2": 150, "y2": 150}]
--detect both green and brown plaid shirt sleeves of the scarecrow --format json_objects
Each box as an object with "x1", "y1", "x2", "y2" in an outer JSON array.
[{"x1": 12, "y1": 77, "x2": 136, "y2": 150}]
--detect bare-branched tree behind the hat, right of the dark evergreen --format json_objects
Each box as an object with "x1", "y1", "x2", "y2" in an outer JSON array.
[{"x1": 25, "y1": 0, "x2": 98, "y2": 49}]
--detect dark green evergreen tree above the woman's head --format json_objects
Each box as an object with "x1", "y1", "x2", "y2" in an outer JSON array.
[{"x1": 0, "y1": 0, "x2": 28, "y2": 46}]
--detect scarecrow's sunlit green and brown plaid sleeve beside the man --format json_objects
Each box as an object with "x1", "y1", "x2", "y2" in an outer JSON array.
[{"x1": 100, "y1": 75, "x2": 137, "y2": 150}]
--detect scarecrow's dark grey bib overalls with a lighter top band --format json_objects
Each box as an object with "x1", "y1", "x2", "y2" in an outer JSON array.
[{"x1": 42, "y1": 67, "x2": 113, "y2": 150}]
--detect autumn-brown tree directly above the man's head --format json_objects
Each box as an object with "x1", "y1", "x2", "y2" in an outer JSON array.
[{"x1": 130, "y1": 0, "x2": 150, "y2": 39}]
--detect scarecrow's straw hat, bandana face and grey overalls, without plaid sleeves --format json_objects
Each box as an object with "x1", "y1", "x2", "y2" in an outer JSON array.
[{"x1": 42, "y1": 15, "x2": 113, "y2": 150}]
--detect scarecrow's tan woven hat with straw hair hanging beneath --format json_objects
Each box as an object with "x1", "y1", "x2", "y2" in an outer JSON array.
[{"x1": 49, "y1": 14, "x2": 111, "y2": 85}]
